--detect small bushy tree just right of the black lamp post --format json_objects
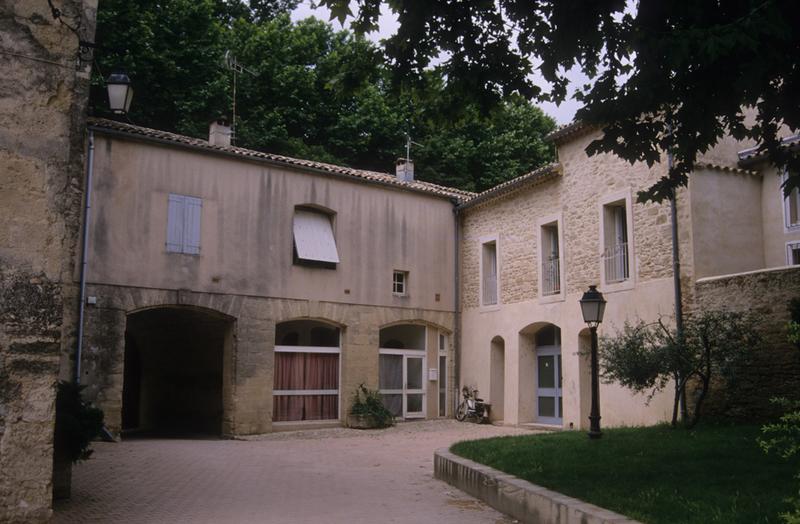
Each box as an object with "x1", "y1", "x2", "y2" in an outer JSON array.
[{"x1": 599, "y1": 311, "x2": 761, "y2": 427}]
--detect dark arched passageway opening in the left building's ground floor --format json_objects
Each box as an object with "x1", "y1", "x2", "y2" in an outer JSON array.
[{"x1": 122, "y1": 307, "x2": 233, "y2": 436}]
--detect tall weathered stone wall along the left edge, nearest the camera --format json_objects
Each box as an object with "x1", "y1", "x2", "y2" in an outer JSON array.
[{"x1": 0, "y1": 0, "x2": 97, "y2": 522}]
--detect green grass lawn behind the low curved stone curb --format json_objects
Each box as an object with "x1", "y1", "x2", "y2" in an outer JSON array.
[{"x1": 451, "y1": 425, "x2": 800, "y2": 524}]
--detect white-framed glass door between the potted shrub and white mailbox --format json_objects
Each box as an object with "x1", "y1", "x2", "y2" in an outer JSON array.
[{"x1": 379, "y1": 349, "x2": 425, "y2": 419}]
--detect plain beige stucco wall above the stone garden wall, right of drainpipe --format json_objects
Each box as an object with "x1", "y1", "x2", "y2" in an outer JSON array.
[{"x1": 689, "y1": 168, "x2": 768, "y2": 278}]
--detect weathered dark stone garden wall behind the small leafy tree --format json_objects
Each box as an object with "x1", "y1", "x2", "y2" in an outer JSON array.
[{"x1": 696, "y1": 267, "x2": 800, "y2": 420}]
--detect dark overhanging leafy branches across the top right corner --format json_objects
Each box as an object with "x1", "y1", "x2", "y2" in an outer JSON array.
[{"x1": 320, "y1": 0, "x2": 800, "y2": 201}]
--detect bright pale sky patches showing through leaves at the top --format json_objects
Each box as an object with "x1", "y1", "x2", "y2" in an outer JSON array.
[{"x1": 292, "y1": 0, "x2": 587, "y2": 125}]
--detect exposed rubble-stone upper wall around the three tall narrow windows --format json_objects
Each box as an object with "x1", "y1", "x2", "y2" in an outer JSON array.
[{"x1": 460, "y1": 130, "x2": 691, "y2": 308}]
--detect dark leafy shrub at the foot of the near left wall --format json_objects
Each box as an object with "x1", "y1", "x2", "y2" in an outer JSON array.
[{"x1": 53, "y1": 381, "x2": 103, "y2": 499}]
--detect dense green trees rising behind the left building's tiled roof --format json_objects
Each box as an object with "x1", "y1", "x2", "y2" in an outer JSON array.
[{"x1": 91, "y1": 0, "x2": 555, "y2": 190}]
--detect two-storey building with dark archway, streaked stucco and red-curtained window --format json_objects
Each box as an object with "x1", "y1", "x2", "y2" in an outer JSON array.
[{"x1": 81, "y1": 120, "x2": 470, "y2": 435}]
